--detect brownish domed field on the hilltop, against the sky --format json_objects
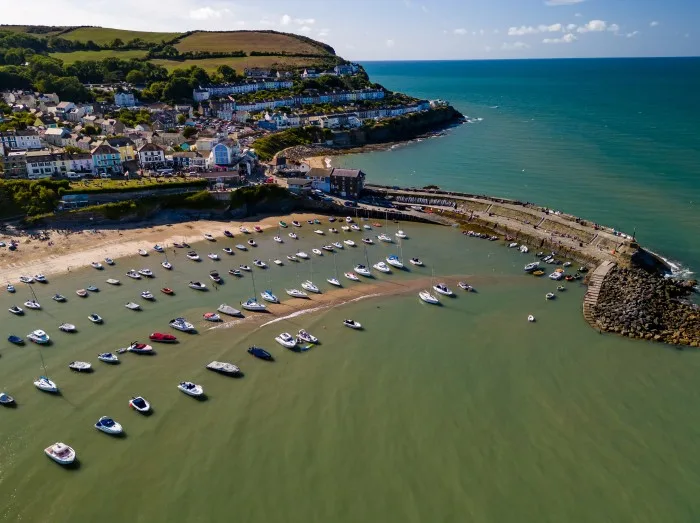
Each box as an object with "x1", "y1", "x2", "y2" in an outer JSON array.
[{"x1": 175, "y1": 31, "x2": 327, "y2": 54}]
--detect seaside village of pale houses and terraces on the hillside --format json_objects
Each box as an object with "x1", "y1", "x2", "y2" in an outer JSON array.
[{"x1": 0, "y1": 64, "x2": 444, "y2": 201}]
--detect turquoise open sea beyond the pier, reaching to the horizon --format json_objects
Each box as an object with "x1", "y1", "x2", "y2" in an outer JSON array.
[{"x1": 336, "y1": 58, "x2": 700, "y2": 271}]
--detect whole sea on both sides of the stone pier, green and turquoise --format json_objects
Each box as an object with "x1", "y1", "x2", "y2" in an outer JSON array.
[{"x1": 0, "y1": 59, "x2": 700, "y2": 523}]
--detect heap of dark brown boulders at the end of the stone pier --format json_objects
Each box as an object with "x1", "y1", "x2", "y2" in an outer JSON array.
[{"x1": 591, "y1": 267, "x2": 700, "y2": 347}]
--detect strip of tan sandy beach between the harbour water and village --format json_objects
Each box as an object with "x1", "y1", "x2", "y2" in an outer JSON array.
[{"x1": 0, "y1": 214, "x2": 317, "y2": 283}]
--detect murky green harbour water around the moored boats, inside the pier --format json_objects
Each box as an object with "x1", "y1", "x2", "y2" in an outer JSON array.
[{"x1": 0, "y1": 220, "x2": 700, "y2": 523}]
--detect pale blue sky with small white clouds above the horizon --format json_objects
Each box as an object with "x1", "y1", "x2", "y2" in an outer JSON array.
[{"x1": 0, "y1": 0, "x2": 700, "y2": 61}]
